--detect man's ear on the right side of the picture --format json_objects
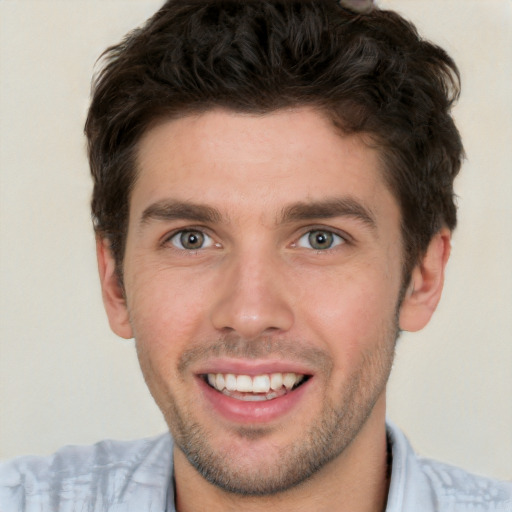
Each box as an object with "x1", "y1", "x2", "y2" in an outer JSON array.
[{"x1": 399, "y1": 228, "x2": 451, "y2": 331}]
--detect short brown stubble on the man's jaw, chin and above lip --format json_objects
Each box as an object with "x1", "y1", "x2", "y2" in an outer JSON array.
[{"x1": 146, "y1": 321, "x2": 398, "y2": 496}]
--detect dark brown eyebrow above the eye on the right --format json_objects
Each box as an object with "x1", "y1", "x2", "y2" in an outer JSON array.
[{"x1": 281, "y1": 197, "x2": 377, "y2": 230}]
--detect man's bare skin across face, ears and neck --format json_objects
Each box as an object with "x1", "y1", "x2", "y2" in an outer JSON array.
[{"x1": 97, "y1": 108, "x2": 450, "y2": 512}]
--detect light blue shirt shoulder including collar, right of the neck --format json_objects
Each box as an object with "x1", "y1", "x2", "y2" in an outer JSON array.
[{"x1": 386, "y1": 424, "x2": 512, "y2": 512}]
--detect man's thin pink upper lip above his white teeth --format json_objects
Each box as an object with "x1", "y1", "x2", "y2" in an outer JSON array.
[{"x1": 195, "y1": 358, "x2": 313, "y2": 376}]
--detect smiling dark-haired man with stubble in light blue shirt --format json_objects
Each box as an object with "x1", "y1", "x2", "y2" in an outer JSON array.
[{"x1": 0, "y1": 1, "x2": 512, "y2": 512}]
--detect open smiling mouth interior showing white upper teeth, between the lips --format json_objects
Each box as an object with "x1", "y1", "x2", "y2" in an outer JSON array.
[{"x1": 201, "y1": 372, "x2": 311, "y2": 402}]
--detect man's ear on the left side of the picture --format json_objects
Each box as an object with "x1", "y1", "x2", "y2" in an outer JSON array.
[{"x1": 96, "y1": 236, "x2": 133, "y2": 339}]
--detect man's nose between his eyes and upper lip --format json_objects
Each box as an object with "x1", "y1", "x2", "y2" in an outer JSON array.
[{"x1": 211, "y1": 251, "x2": 294, "y2": 339}]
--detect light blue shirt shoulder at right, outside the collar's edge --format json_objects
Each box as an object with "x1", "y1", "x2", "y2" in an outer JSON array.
[{"x1": 418, "y1": 458, "x2": 512, "y2": 512}]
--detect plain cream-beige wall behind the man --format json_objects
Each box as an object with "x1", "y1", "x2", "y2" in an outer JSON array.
[{"x1": 0, "y1": 0, "x2": 512, "y2": 478}]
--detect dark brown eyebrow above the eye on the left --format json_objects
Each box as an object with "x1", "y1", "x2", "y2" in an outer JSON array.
[{"x1": 140, "y1": 200, "x2": 222, "y2": 226}]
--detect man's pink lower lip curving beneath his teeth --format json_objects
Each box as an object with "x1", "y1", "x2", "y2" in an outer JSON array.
[{"x1": 197, "y1": 377, "x2": 313, "y2": 424}]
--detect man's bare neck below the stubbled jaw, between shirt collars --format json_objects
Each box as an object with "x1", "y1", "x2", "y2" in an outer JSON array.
[{"x1": 174, "y1": 396, "x2": 389, "y2": 512}]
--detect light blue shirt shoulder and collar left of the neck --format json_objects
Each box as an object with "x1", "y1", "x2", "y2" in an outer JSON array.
[{"x1": 0, "y1": 434, "x2": 172, "y2": 512}]
